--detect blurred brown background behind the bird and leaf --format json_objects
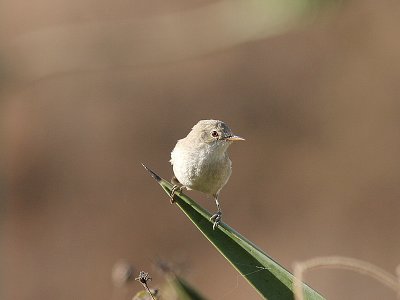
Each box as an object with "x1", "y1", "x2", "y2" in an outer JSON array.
[{"x1": 0, "y1": 0, "x2": 400, "y2": 300}]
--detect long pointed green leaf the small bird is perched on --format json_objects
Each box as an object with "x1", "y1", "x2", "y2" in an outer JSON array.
[{"x1": 143, "y1": 165, "x2": 324, "y2": 300}]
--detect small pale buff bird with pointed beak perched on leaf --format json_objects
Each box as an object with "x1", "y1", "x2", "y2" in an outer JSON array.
[{"x1": 170, "y1": 120, "x2": 244, "y2": 230}]
